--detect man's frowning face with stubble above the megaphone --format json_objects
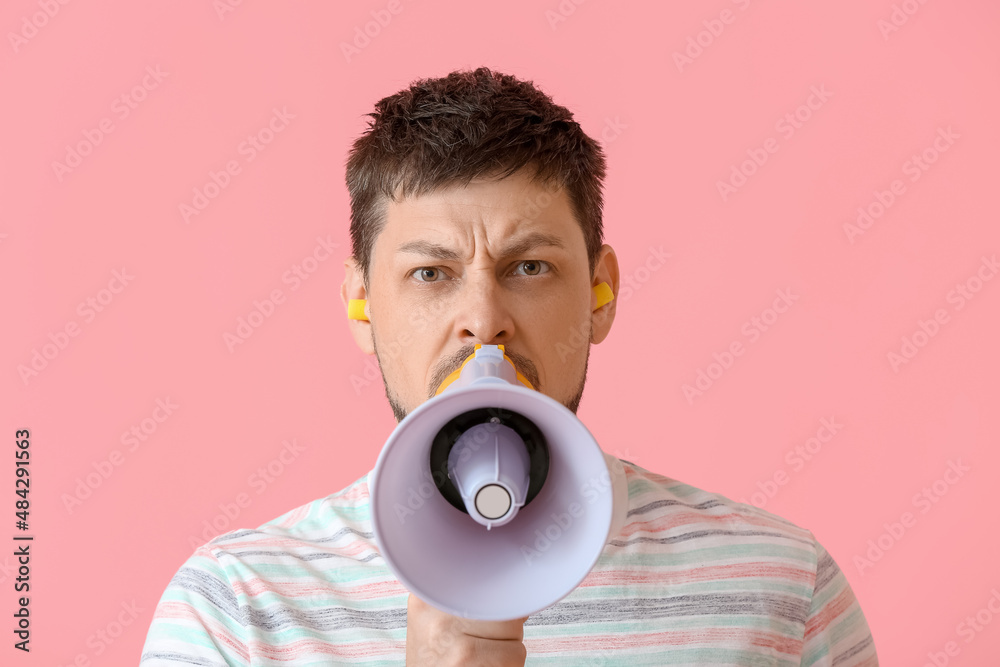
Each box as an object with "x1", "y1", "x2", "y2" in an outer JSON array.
[{"x1": 345, "y1": 171, "x2": 618, "y2": 420}]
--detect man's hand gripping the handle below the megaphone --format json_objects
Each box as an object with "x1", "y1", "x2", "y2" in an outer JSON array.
[{"x1": 406, "y1": 594, "x2": 528, "y2": 667}]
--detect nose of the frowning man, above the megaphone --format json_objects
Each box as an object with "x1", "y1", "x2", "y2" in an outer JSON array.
[{"x1": 455, "y1": 270, "x2": 514, "y2": 345}]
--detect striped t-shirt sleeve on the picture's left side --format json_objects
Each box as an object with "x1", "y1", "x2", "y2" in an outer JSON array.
[{"x1": 140, "y1": 545, "x2": 250, "y2": 667}]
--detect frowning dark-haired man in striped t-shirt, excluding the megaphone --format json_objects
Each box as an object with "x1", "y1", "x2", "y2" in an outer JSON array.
[{"x1": 142, "y1": 68, "x2": 878, "y2": 666}]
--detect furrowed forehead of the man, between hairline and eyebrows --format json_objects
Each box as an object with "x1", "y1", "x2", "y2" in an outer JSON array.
[{"x1": 376, "y1": 170, "x2": 586, "y2": 253}]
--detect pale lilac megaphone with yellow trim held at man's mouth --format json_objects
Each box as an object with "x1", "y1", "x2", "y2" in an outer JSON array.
[{"x1": 368, "y1": 345, "x2": 628, "y2": 621}]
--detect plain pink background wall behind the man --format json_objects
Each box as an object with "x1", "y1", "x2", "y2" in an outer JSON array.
[{"x1": 0, "y1": 0, "x2": 1000, "y2": 665}]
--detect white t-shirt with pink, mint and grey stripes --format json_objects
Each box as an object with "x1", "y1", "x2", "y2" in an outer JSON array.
[{"x1": 142, "y1": 461, "x2": 878, "y2": 667}]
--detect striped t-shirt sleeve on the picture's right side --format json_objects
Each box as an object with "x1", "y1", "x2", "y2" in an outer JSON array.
[{"x1": 801, "y1": 536, "x2": 878, "y2": 667}]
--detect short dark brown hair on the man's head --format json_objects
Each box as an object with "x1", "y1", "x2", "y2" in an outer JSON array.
[{"x1": 346, "y1": 67, "x2": 606, "y2": 286}]
